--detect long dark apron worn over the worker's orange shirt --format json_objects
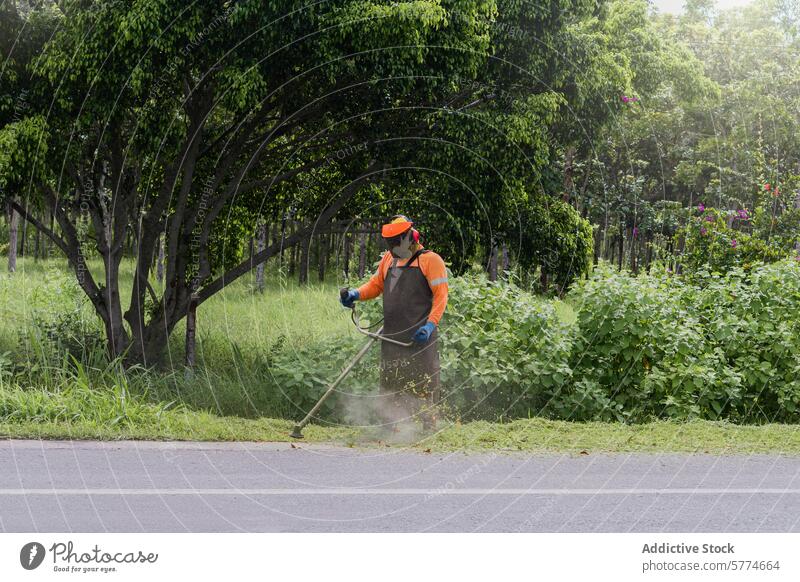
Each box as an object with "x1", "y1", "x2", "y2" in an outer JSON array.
[{"x1": 381, "y1": 249, "x2": 439, "y2": 422}]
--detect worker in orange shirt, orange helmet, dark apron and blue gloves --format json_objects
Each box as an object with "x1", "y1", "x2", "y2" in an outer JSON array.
[{"x1": 341, "y1": 214, "x2": 448, "y2": 429}]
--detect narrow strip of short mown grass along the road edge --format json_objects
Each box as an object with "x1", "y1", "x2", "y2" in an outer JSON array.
[{"x1": 0, "y1": 418, "x2": 800, "y2": 455}]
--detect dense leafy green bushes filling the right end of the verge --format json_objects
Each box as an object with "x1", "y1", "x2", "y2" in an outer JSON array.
[{"x1": 558, "y1": 259, "x2": 800, "y2": 422}]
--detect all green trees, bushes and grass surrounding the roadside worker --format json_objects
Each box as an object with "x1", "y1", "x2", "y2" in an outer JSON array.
[{"x1": 0, "y1": 0, "x2": 800, "y2": 450}]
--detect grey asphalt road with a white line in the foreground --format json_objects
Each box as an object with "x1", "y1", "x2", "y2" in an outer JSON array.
[{"x1": 0, "y1": 440, "x2": 800, "y2": 532}]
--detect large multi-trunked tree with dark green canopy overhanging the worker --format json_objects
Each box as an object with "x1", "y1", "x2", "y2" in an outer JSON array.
[{"x1": 4, "y1": 0, "x2": 632, "y2": 364}]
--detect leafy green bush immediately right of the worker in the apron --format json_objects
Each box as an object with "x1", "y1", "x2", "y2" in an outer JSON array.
[{"x1": 441, "y1": 275, "x2": 572, "y2": 419}]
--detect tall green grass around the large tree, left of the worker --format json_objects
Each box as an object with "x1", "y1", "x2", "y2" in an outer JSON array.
[{"x1": 0, "y1": 257, "x2": 368, "y2": 423}]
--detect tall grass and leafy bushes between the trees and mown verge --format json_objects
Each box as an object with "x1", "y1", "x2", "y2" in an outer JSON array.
[{"x1": 0, "y1": 259, "x2": 800, "y2": 436}]
